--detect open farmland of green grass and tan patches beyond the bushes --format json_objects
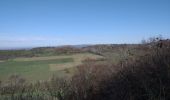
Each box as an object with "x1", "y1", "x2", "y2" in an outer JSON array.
[{"x1": 0, "y1": 53, "x2": 102, "y2": 81}]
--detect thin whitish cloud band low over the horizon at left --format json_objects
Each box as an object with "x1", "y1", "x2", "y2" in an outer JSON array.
[{"x1": 0, "y1": 36, "x2": 63, "y2": 49}]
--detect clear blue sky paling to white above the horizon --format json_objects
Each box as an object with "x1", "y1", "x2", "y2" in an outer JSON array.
[{"x1": 0, "y1": 0, "x2": 170, "y2": 49}]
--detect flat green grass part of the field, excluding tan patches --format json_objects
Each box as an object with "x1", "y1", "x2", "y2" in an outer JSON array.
[{"x1": 0, "y1": 58, "x2": 73, "y2": 80}]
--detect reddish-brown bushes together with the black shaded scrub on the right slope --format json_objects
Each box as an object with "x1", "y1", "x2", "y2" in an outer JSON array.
[{"x1": 63, "y1": 41, "x2": 170, "y2": 100}]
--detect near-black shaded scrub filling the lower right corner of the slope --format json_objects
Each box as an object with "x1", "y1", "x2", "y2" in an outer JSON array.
[{"x1": 91, "y1": 41, "x2": 170, "y2": 100}]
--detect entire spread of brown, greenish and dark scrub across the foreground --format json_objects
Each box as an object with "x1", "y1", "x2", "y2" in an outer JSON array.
[{"x1": 0, "y1": 39, "x2": 170, "y2": 100}]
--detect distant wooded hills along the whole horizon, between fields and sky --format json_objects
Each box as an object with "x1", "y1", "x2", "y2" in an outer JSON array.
[{"x1": 0, "y1": 39, "x2": 170, "y2": 60}]
